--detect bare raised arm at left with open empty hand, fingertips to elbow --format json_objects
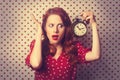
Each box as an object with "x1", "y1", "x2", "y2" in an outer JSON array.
[{"x1": 30, "y1": 14, "x2": 42, "y2": 69}]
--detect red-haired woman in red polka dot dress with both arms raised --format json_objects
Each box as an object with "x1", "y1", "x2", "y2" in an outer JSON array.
[{"x1": 26, "y1": 7, "x2": 100, "y2": 80}]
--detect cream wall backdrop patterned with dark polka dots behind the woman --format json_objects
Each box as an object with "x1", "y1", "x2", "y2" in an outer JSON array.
[{"x1": 0, "y1": 0, "x2": 120, "y2": 80}]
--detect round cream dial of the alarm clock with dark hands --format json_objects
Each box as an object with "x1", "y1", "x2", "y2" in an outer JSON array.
[{"x1": 74, "y1": 23, "x2": 87, "y2": 36}]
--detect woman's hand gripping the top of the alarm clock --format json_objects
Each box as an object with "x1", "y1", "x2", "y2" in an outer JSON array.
[{"x1": 80, "y1": 11, "x2": 96, "y2": 25}]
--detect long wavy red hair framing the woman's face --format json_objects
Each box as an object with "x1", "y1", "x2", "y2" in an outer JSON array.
[{"x1": 42, "y1": 7, "x2": 77, "y2": 63}]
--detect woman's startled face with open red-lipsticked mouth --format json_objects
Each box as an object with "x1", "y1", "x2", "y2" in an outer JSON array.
[{"x1": 45, "y1": 14, "x2": 65, "y2": 45}]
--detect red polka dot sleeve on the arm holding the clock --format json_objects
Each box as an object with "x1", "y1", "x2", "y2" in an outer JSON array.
[{"x1": 76, "y1": 42, "x2": 91, "y2": 63}]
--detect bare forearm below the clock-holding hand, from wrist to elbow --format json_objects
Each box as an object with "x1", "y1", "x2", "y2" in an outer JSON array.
[{"x1": 85, "y1": 22, "x2": 100, "y2": 61}]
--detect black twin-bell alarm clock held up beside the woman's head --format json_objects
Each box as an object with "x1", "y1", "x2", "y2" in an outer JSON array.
[{"x1": 72, "y1": 18, "x2": 87, "y2": 37}]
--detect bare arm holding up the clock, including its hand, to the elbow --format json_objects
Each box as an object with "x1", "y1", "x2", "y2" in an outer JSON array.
[{"x1": 81, "y1": 11, "x2": 100, "y2": 61}]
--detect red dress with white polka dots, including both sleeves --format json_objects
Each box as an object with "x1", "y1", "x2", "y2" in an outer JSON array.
[{"x1": 26, "y1": 40, "x2": 89, "y2": 80}]
